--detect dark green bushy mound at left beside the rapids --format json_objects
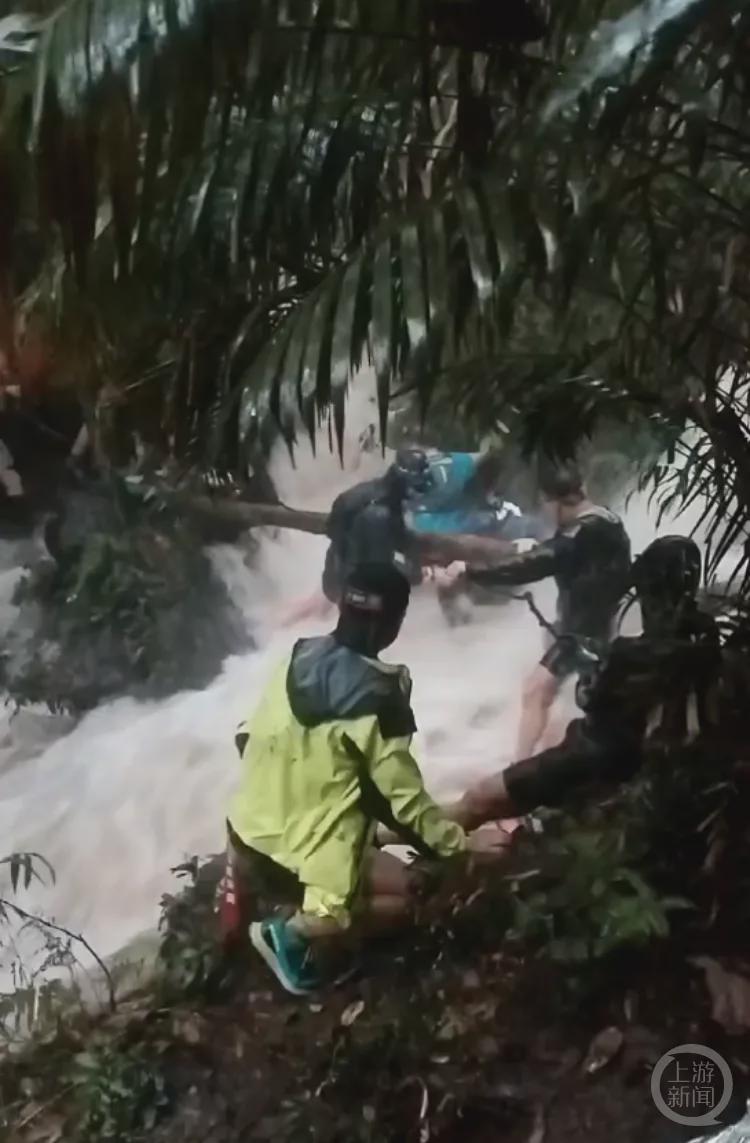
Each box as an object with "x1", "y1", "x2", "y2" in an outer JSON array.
[{"x1": 7, "y1": 475, "x2": 249, "y2": 711}]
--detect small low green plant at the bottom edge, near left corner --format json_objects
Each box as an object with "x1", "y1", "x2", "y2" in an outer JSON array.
[{"x1": 71, "y1": 1044, "x2": 168, "y2": 1143}]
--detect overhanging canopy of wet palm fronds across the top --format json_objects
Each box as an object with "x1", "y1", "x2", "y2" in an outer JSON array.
[{"x1": 3, "y1": 0, "x2": 750, "y2": 585}]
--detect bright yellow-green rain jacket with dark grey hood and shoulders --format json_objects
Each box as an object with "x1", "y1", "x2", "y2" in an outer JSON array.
[{"x1": 229, "y1": 636, "x2": 465, "y2": 925}]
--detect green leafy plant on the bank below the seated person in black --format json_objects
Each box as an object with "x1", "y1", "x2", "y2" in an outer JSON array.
[{"x1": 509, "y1": 815, "x2": 688, "y2": 965}]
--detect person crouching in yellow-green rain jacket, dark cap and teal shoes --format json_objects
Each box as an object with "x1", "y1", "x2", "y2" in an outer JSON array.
[{"x1": 228, "y1": 565, "x2": 506, "y2": 994}]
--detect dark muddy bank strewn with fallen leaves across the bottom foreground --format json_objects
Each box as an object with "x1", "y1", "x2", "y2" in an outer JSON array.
[{"x1": 0, "y1": 868, "x2": 750, "y2": 1143}]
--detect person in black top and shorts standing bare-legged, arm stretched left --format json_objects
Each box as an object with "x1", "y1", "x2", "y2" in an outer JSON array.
[{"x1": 445, "y1": 469, "x2": 630, "y2": 758}]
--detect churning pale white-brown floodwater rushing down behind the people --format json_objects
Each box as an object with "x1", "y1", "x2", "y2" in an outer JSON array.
[{"x1": 0, "y1": 386, "x2": 736, "y2": 983}]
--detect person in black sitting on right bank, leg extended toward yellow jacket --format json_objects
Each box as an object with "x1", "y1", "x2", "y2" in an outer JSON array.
[{"x1": 450, "y1": 536, "x2": 721, "y2": 829}]
